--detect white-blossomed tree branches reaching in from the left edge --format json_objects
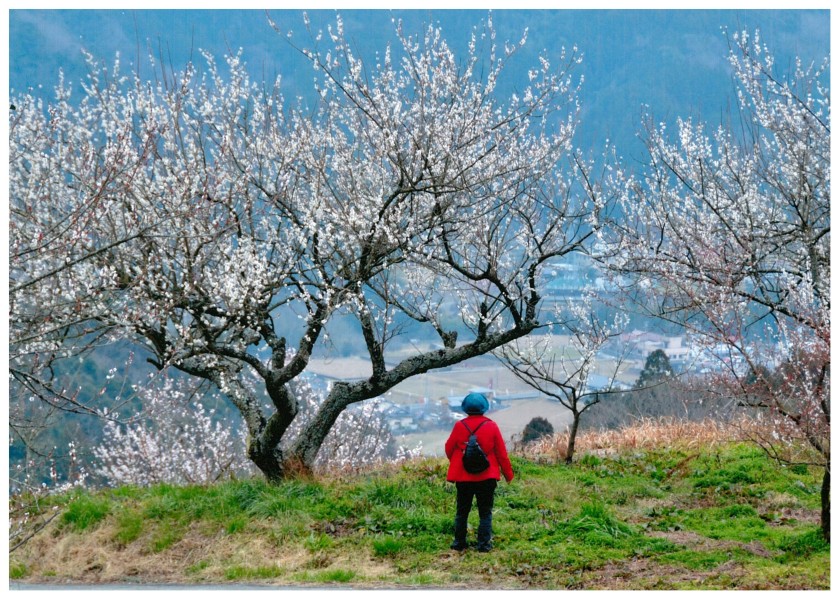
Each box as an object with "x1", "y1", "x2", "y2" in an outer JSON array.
[{"x1": 9, "y1": 66, "x2": 158, "y2": 426}]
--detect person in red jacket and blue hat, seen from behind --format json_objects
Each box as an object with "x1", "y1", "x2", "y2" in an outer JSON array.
[{"x1": 445, "y1": 392, "x2": 513, "y2": 552}]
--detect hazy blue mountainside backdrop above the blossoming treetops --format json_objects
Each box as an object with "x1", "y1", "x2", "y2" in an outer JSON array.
[{"x1": 7, "y1": 3, "x2": 830, "y2": 156}]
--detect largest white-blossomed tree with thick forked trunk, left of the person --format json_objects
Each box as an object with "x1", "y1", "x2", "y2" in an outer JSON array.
[{"x1": 10, "y1": 12, "x2": 606, "y2": 480}]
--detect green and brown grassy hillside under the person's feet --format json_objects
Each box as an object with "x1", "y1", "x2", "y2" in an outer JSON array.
[{"x1": 9, "y1": 422, "x2": 830, "y2": 589}]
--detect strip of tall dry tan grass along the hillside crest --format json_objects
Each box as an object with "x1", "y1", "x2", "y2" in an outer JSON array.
[{"x1": 517, "y1": 418, "x2": 759, "y2": 461}]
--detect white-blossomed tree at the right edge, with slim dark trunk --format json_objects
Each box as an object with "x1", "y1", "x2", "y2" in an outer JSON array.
[{"x1": 613, "y1": 33, "x2": 831, "y2": 539}]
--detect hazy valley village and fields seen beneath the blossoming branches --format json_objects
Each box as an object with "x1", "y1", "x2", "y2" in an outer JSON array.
[{"x1": 307, "y1": 251, "x2": 760, "y2": 454}]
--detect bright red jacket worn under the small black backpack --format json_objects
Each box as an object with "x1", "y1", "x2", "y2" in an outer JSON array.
[{"x1": 445, "y1": 415, "x2": 513, "y2": 481}]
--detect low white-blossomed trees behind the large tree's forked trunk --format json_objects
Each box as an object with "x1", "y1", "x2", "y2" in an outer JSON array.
[{"x1": 93, "y1": 373, "x2": 419, "y2": 485}]
